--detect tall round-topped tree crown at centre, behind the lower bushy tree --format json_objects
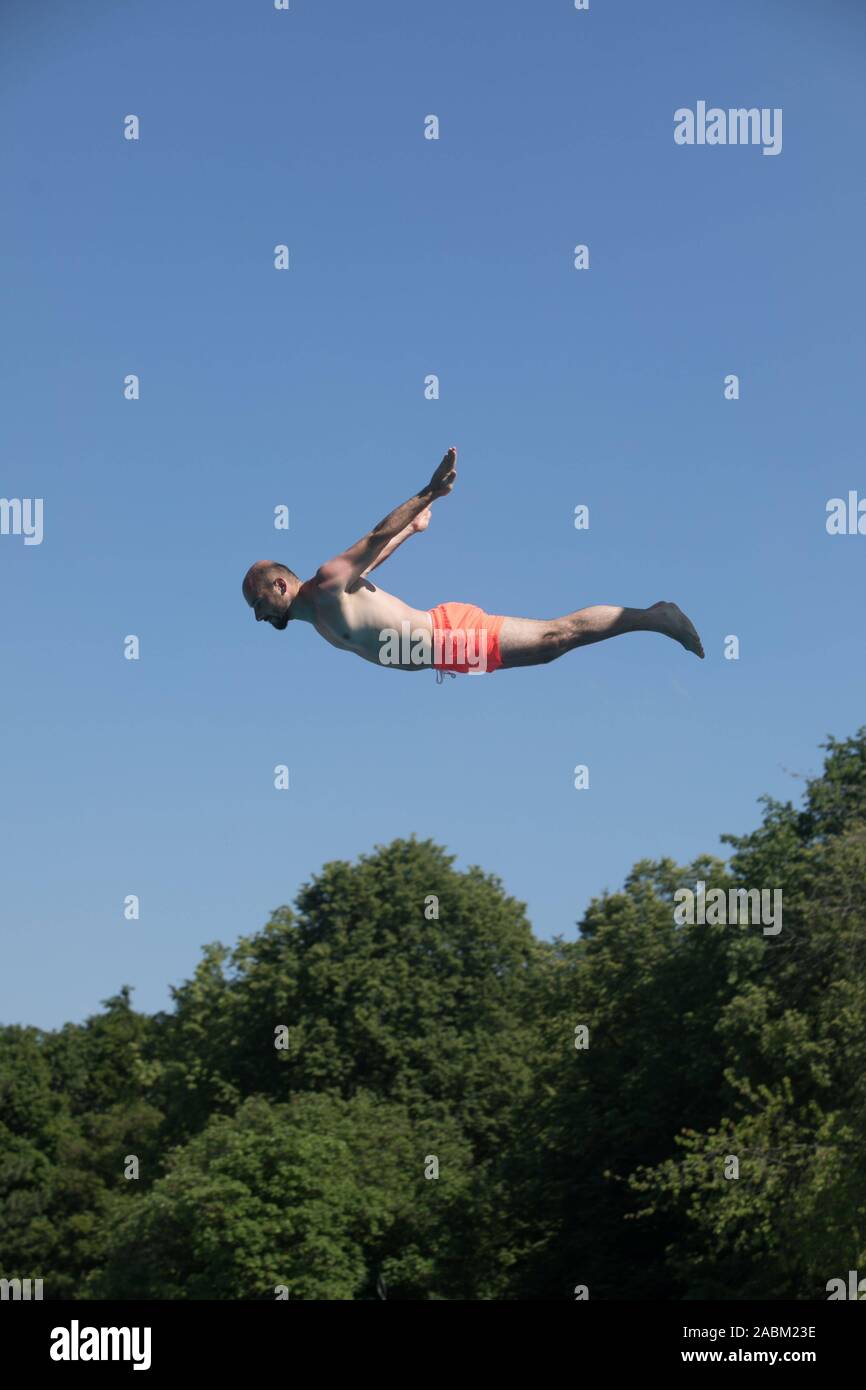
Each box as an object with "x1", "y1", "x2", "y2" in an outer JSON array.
[{"x1": 148, "y1": 840, "x2": 541, "y2": 1156}]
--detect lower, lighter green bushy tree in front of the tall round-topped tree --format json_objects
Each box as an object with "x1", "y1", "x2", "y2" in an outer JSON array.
[{"x1": 90, "y1": 1093, "x2": 471, "y2": 1300}]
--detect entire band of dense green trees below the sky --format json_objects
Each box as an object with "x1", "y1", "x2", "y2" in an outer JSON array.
[{"x1": 0, "y1": 730, "x2": 866, "y2": 1300}]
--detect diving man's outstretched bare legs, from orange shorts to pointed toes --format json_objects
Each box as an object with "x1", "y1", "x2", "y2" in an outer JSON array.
[{"x1": 499, "y1": 603, "x2": 703, "y2": 667}]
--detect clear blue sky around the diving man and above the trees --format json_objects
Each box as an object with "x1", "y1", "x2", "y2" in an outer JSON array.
[{"x1": 0, "y1": 0, "x2": 866, "y2": 1026}]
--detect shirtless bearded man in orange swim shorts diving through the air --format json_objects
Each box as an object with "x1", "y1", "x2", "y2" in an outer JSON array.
[{"x1": 243, "y1": 449, "x2": 703, "y2": 680}]
